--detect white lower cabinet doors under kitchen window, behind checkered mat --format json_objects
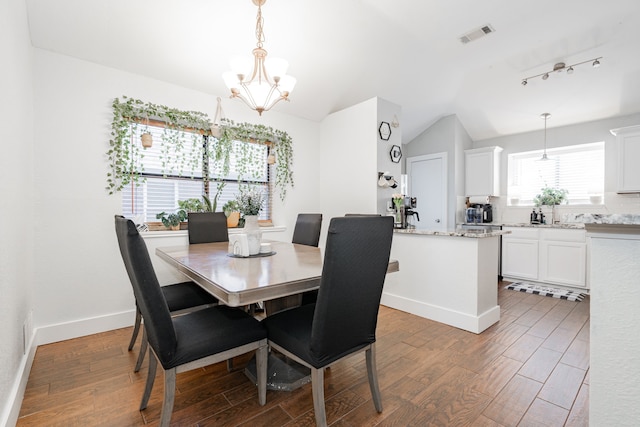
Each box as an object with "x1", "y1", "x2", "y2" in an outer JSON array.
[{"x1": 502, "y1": 227, "x2": 587, "y2": 288}]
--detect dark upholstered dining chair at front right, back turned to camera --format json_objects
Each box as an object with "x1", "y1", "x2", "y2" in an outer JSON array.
[{"x1": 262, "y1": 216, "x2": 393, "y2": 426}]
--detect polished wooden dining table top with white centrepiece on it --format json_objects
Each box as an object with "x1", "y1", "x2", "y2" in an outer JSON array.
[{"x1": 156, "y1": 241, "x2": 398, "y2": 307}]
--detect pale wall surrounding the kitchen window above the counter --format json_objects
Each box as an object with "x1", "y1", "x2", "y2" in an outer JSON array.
[{"x1": 473, "y1": 114, "x2": 640, "y2": 222}]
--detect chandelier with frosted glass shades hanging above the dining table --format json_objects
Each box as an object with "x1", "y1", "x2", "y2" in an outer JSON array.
[{"x1": 222, "y1": 0, "x2": 296, "y2": 115}]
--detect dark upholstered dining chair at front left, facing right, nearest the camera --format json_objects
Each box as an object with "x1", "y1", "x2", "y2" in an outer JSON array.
[{"x1": 115, "y1": 217, "x2": 268, "y2": 426}]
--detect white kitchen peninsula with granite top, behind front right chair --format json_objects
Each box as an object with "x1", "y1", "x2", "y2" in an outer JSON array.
[{"x1": 381, "y1": 229, "x2": 508, "y2": 334}]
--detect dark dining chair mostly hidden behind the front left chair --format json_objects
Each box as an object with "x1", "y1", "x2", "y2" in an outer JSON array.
[{"x1": 116, "y1": 215, "x2": 218, "y2": 372}]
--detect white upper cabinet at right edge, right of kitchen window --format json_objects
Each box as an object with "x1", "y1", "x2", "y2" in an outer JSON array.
[{"x1": 611, "y1": 126, "x2": 640, "y2": 193}]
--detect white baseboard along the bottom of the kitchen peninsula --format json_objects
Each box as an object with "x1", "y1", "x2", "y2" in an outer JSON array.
[{"x1": 380, "y1": 292, "x2": 500, "y2": 334}]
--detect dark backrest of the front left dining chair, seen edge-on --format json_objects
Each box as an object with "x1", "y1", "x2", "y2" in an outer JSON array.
[{"x1": 115, "y1": 215, "x2": 177, "y2": 366}]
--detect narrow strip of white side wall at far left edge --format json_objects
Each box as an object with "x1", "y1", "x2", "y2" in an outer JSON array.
[{"x1": 0, "y1": 0, "x2": 34, "y2": 425}]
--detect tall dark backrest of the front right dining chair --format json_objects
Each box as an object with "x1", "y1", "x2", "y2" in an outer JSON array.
[{"x1": 310, "y1": 216, "x2": 393, "y2": 365}]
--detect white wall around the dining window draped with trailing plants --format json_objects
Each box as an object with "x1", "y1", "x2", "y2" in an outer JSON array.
[{"x1": 29, "y1": 49, "x2": 320, "y2": 343}]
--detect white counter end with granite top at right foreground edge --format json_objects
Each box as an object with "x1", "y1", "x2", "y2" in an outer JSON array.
[{"x1": 585, "y1": 222, "x2": 640, "y2": 426}]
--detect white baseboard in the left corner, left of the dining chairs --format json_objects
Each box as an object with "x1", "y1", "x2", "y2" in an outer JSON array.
[{"x1": 0, "y1": 310, "x2": 135, "y2": 426}]
